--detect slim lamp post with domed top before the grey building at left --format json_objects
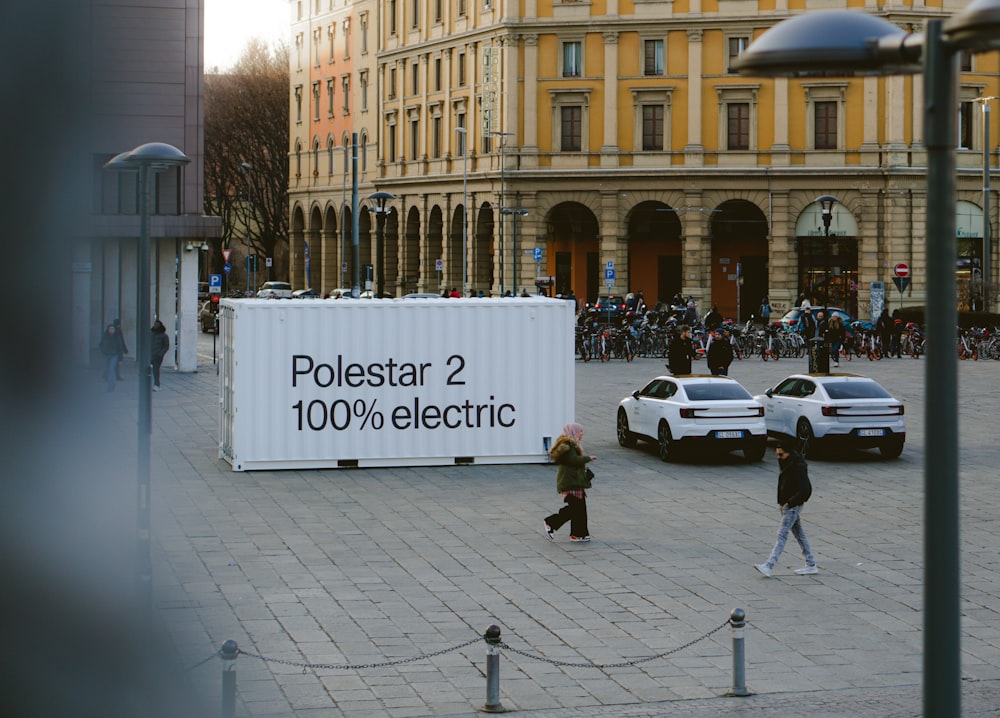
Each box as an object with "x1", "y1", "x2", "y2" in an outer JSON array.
[{"x1": 104, "y1": 142, "x2": 191, "y2": 618}]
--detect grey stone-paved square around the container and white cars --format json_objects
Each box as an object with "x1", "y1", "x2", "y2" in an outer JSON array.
[{"x1": 95, "y1": 337, "x2": 1000, "y2": 718}]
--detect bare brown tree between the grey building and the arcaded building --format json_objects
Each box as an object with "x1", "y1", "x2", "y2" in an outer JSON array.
[{"x1": 205, "y1": 40, "x2": 288, "y2": 288}]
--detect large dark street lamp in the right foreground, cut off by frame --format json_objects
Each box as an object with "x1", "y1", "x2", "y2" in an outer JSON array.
[{"x1": 734, "y1": 0, "x2": 1000, "y2": 716}]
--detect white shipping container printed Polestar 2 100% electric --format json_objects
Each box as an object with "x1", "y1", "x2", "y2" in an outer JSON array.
[{"x1": 219, "y1": 297, "x2": 575, "y2": 471}]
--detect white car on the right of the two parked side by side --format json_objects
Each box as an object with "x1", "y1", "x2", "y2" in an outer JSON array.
[{"x1": 755, "y1": 374, "x2": 906, "y2": 459}]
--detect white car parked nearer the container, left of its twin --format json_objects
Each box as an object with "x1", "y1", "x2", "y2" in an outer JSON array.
[{"x1": 617, "y1": 375, "x2": 767, "y2": 461}]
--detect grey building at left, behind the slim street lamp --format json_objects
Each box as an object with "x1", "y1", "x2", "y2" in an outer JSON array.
[{"x1": 79, "y1": 0, "x2": 221, "y2": 371}]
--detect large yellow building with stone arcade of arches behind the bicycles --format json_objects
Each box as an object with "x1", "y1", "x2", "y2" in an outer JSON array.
[{"x1": 290, "y1": 0, "x2": 1000, "y2": 319}]
